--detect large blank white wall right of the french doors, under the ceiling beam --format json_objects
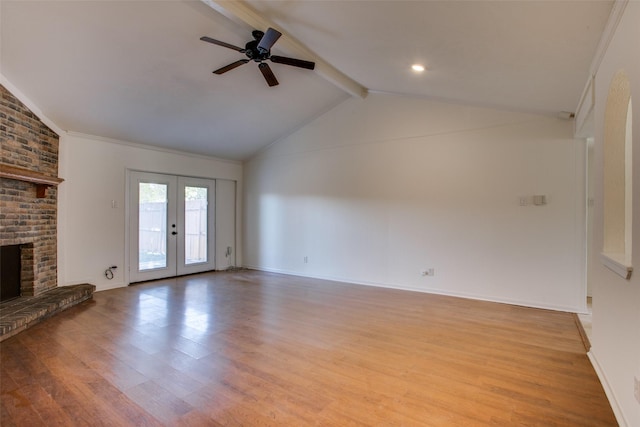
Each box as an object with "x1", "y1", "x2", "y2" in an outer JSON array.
[{"x1": 244, "y1": 94, "x2": 586, "y2": 311}]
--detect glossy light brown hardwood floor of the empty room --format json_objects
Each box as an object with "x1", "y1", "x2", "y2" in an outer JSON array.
[{"x1": 0, "y1": 271, "x2": 617, "y2": 427}]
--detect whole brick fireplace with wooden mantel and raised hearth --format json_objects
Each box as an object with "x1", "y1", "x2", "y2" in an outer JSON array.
[{"x1": 0, "y1": 85, "x2": 96, "y2": 342}]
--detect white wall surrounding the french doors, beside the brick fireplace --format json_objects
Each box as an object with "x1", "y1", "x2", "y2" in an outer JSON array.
[{"x1": 58, "y1": 134, "x2": 242, "y2": 290}]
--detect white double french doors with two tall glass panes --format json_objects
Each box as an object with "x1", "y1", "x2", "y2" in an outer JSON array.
[{"x1": 129, "y1": 172, "x2": 216, "y2": 282}]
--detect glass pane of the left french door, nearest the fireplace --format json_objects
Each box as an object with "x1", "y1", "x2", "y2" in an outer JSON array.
[{"x1": 138, "y1": 182, "x2": 168, "y2": 271}]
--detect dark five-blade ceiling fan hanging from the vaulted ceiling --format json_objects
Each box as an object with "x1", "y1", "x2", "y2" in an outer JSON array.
[{"x1": 200, "y1": 28, "x2": 316, "y2": 86}]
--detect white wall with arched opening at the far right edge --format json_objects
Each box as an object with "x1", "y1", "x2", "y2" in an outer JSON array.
[{"x1": 590, "y1": 1, "x2": 640, "y2": 426}]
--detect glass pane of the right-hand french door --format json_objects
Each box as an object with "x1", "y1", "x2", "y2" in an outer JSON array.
[{"x1": 184, "y1": 186, "x2": 207, "y2": 264}]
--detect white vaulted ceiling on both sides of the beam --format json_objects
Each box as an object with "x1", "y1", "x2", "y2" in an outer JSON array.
[{"x1": 0, "y1": 0, "x2": 612, "y2": 160}]
